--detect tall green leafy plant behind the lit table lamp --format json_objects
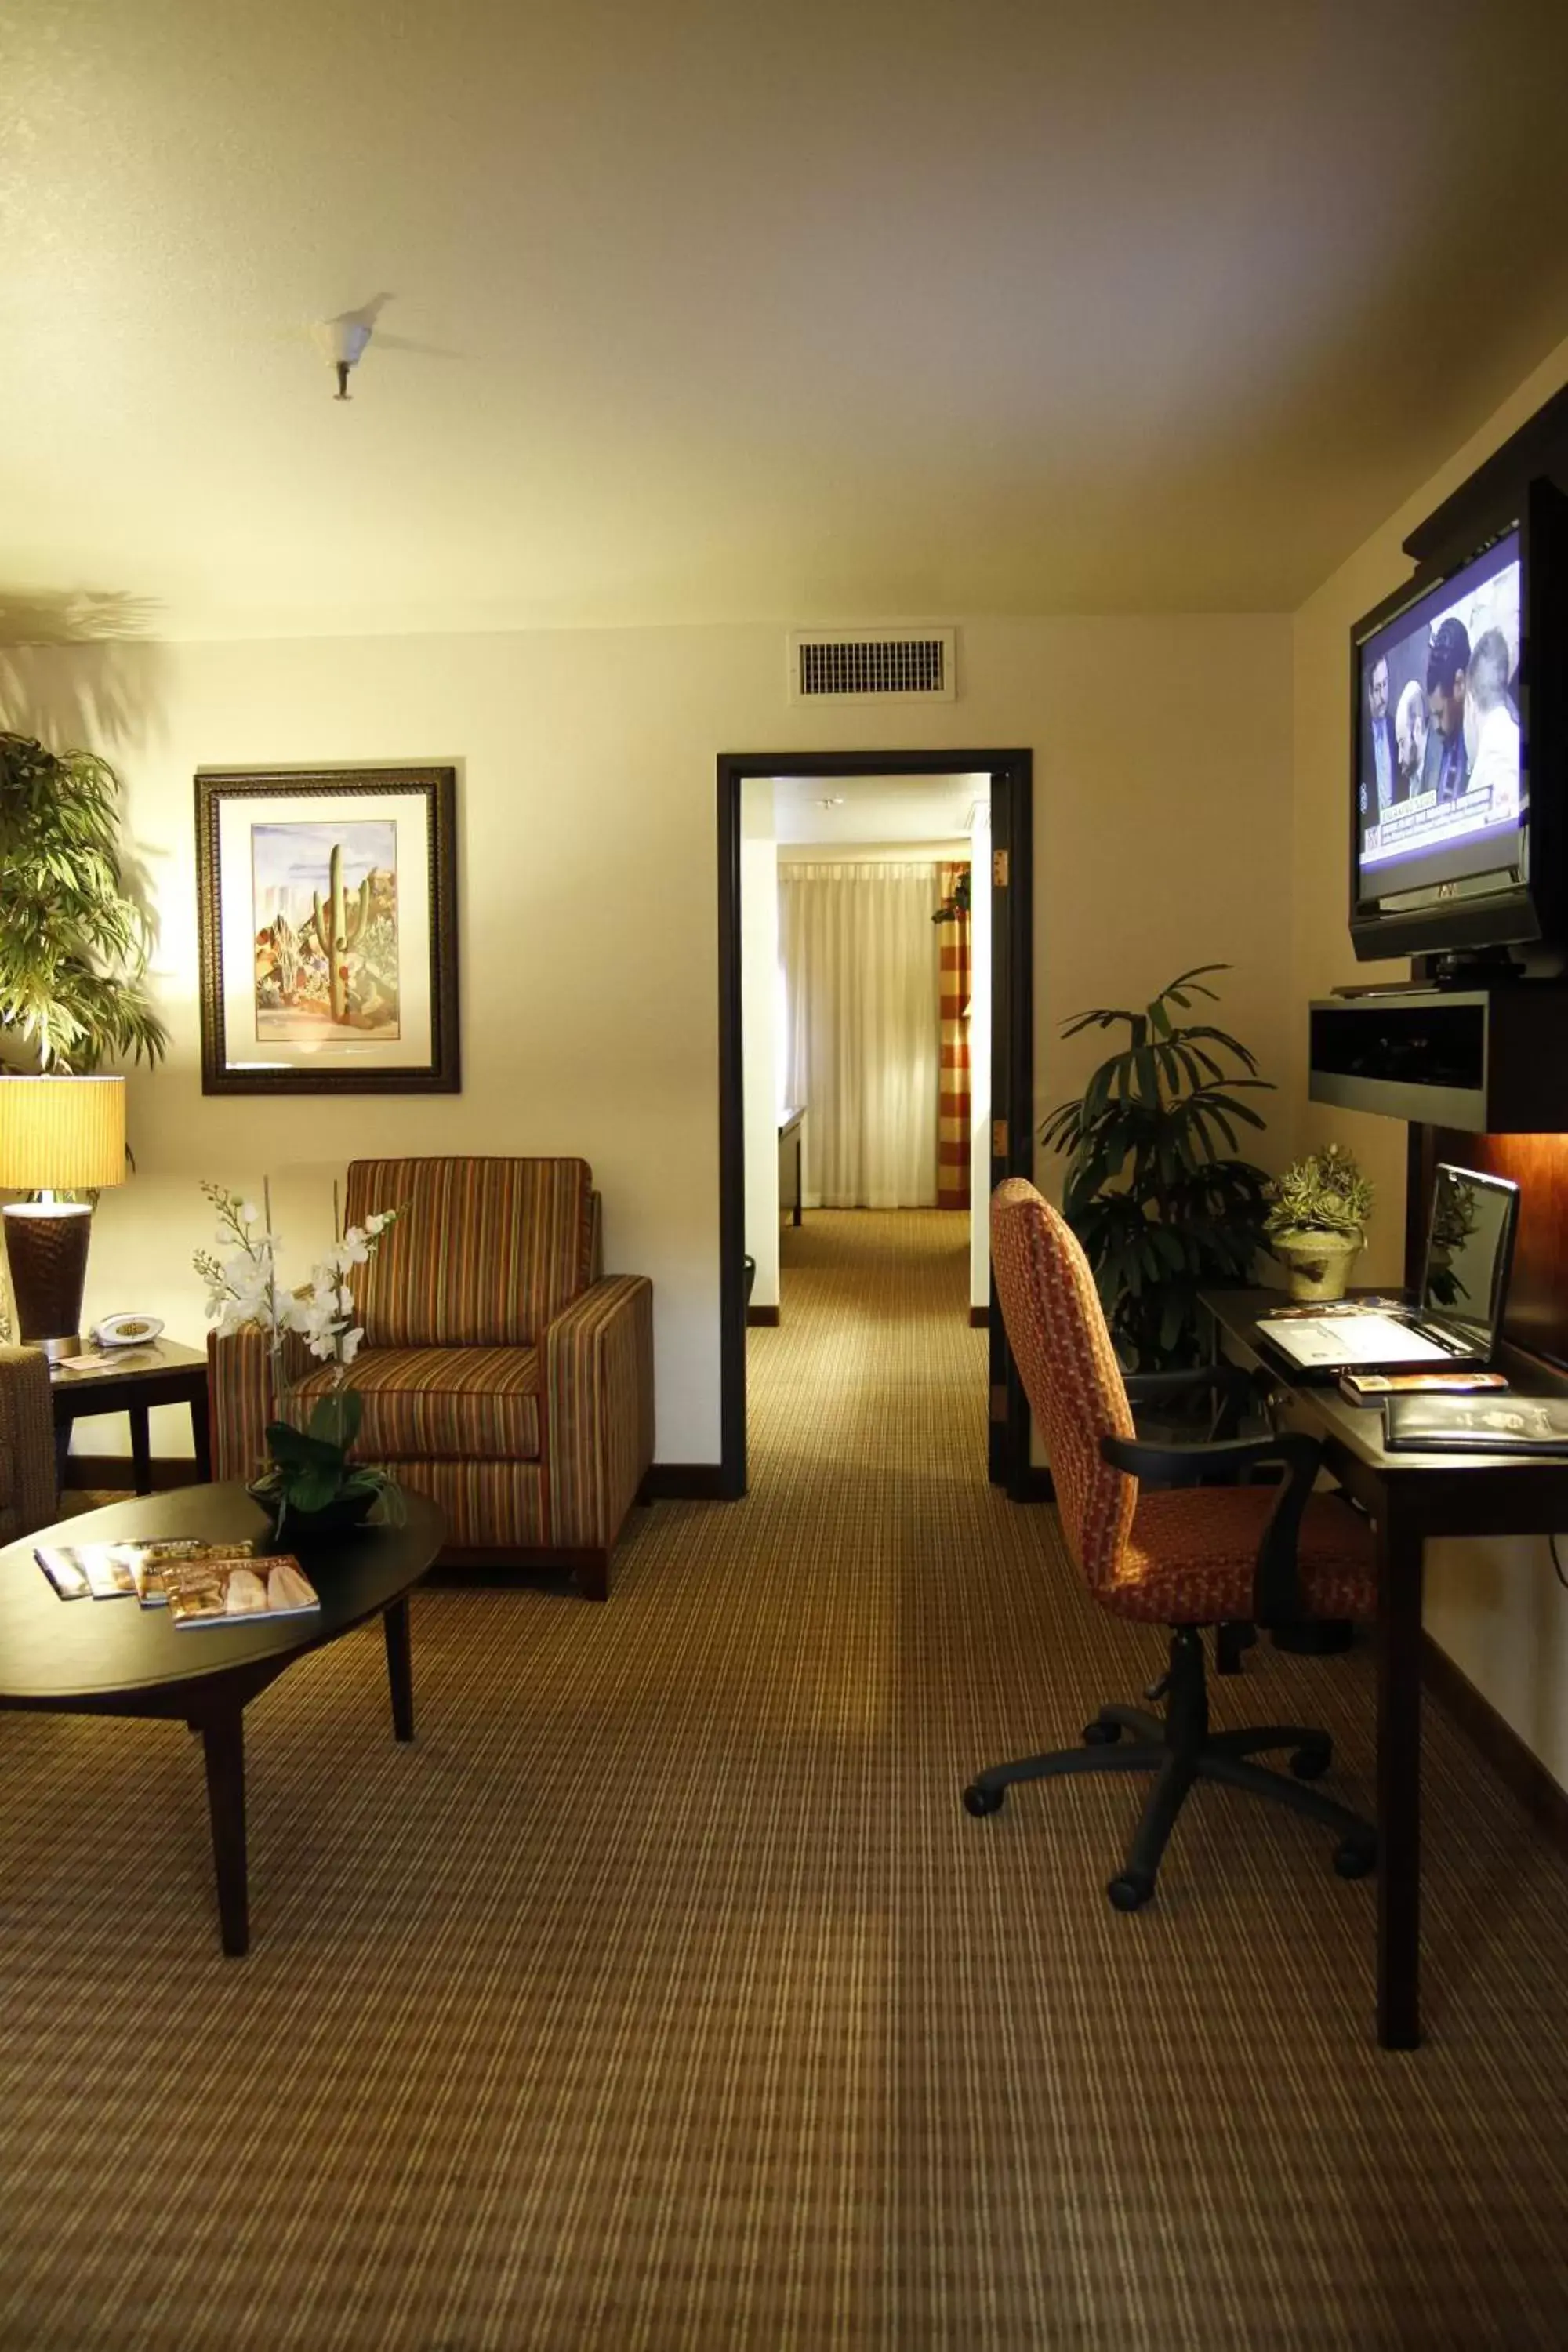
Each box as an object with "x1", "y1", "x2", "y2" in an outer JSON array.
[{"x1": 0, "y1": 734, "x2": 167, "y2": 1075}]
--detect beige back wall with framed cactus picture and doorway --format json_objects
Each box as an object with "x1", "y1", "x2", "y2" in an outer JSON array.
[{"x1": 0, "y1": 597, "x2": 1298, "y2": 1461}]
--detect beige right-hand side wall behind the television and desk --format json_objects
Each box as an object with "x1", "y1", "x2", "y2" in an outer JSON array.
[{"x1": 1293, "y1": 318, "x2": 1568, "y2": 1783}]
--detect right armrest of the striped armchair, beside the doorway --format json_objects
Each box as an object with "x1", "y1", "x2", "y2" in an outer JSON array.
[{"x1": 543, "y1": 1275, "x2": 654, "y2": 1552}]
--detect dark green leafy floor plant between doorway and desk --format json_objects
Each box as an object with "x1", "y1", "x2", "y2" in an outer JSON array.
[{"x1": 1039, "y1": 964, "x2": 1272, "y2": 1371}]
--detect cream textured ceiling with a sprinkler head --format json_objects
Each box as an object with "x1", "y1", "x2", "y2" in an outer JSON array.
[{"x1": 0, "y1": 0, "x2": 1568, "y2": 635}]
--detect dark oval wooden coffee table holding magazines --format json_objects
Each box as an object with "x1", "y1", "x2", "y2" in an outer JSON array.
[{"x1": 0, "y1": 1486, "x2": 442, "y2": 1957}]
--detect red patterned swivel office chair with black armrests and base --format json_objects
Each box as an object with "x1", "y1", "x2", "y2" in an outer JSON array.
[{"x1": 964, "y1": 1176, "x2": 1377, "y2": 1910}]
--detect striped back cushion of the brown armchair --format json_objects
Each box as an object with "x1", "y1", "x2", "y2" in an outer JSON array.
[{"x1": 348, "y1": 1160, "x2": 595, "y2": 1348}]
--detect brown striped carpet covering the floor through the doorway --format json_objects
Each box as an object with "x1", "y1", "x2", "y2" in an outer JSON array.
[{"x1": 0, "y1": 1214, "x2": 1568, "y2": 2352}]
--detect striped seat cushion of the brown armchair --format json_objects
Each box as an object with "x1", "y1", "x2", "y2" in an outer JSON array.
[{"x1": 289, "y1": 1348, "x2": 541, "y2": 1463}]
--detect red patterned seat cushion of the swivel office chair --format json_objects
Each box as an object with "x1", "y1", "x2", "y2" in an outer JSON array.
[{"x1": 1102, "y1": 1486, "x2": 1377, "y2": 1625}]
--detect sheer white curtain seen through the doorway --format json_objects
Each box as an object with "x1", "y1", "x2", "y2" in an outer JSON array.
[{"x1": 779, "y1": 858, "x2": 942, "y2": 1209}]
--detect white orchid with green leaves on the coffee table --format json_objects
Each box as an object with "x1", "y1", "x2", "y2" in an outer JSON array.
[{"x1": 193, "y1": 1183, "x2": 402, "y2": 1538}]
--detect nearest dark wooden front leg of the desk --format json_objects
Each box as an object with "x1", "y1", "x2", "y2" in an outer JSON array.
[{"x1": 1377, "y1": 1494, "x2": 1422, "y2": 2051}]
